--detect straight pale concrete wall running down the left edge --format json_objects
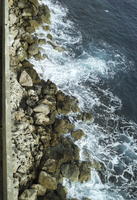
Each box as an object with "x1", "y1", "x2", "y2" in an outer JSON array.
[{"x1": 1, "y1": 0, "x2": 14, "y2": 200}]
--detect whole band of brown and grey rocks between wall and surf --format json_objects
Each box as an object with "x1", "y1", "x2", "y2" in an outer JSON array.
[{"x1": 9, "y1": 0, "x2": 96, "y2": 200}]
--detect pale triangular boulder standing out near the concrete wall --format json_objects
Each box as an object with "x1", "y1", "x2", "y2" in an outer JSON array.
[{"x1": 19, "y1": 71, "x2": 33, "y2": 87}]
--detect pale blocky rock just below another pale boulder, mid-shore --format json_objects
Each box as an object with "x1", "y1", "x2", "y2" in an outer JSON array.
[{"x1": 35, "y1": 113, "x2": 50, "y2": 125}]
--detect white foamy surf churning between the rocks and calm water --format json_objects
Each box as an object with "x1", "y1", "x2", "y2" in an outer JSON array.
[{"x1": 31, "y1": 0, "x2": 137, "y2": 200}]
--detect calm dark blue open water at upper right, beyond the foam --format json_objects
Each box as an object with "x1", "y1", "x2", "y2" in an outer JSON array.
[{"x1": 60, "y1": 0, "x2": 137, "y2": 122}]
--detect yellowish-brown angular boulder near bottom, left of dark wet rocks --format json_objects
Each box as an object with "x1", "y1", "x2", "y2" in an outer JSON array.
[{"x1": 39, "y1": 171, "x2": 57, "y2": 190}]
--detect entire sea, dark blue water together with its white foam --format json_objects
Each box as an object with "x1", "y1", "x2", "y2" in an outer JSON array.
[{"x1": 33, "y1": 0, "x2": 137, "y2": 200}]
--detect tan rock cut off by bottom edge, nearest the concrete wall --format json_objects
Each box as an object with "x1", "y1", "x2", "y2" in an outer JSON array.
[{"x1": 19, "y1": 189, "x2": 37, "y2": 200}]
